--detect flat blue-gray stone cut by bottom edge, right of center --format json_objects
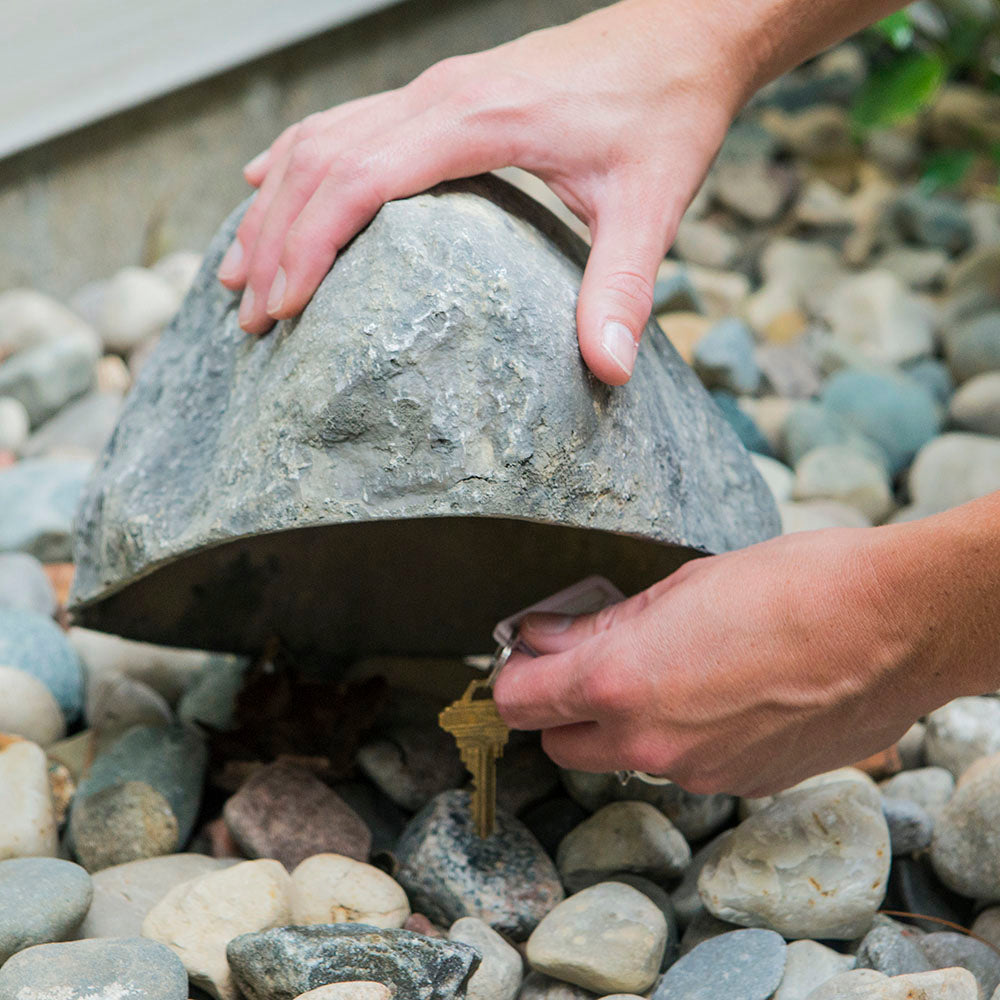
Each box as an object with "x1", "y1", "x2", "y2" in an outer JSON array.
[{"x1": 652, "y1": 930, "x2": 788, "y2": 1000}]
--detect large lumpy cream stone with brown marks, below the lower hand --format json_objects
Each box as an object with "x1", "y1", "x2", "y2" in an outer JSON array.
[{"x1": 698, "y1": 782, "x2": 891, "y2": 938}]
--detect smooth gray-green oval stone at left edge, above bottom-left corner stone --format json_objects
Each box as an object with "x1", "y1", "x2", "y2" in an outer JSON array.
[{"x1": 0, "y1": 858, "x2": 92, "y2": 965}]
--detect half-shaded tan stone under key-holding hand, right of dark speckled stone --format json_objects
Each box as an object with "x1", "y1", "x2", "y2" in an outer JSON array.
[{"x1": 556, "y1": 802, "x2": 691, "y2": 890}]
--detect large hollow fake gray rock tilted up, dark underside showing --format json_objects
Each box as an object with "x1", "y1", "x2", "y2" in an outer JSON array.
[{"x1": 73, "y1": 178, "x2": 778, "y2": 662}]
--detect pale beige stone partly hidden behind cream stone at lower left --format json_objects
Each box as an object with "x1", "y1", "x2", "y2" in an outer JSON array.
[{"x1": 77, "y1": 854, "x2": 236, "y2": 938}]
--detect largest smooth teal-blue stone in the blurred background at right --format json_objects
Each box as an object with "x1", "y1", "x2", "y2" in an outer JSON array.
[{"x1": 822, "y1": 371, "x2": 941, "y2": 474}]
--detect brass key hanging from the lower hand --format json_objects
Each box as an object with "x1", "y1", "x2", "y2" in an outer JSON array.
[{"x1": 438, "y1": 679, "x2": 510, "y2": 838}]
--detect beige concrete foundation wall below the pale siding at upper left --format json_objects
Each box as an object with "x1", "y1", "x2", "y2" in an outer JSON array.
[{"x1": 0, "y1": 0, "x2": 602, "y2": 297}]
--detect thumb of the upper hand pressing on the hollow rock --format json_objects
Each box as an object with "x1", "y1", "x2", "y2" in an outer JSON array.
[{"x1": 576, "y1": 197, "x2": 673, "y2": 385}]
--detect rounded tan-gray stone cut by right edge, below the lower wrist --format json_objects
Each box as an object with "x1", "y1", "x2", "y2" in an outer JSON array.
[{"x1": 931, "y1": 754, "x2": 1000, "y2": 902}]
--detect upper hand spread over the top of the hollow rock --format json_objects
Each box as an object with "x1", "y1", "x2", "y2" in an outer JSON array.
[{"x1": 219, "y1": 0, "x2": 754, "y2": 385}]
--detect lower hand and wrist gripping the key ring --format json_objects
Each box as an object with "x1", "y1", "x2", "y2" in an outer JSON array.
[{"x1": 494, "y1": 494, "x2": 1000, "y2": 796}]
